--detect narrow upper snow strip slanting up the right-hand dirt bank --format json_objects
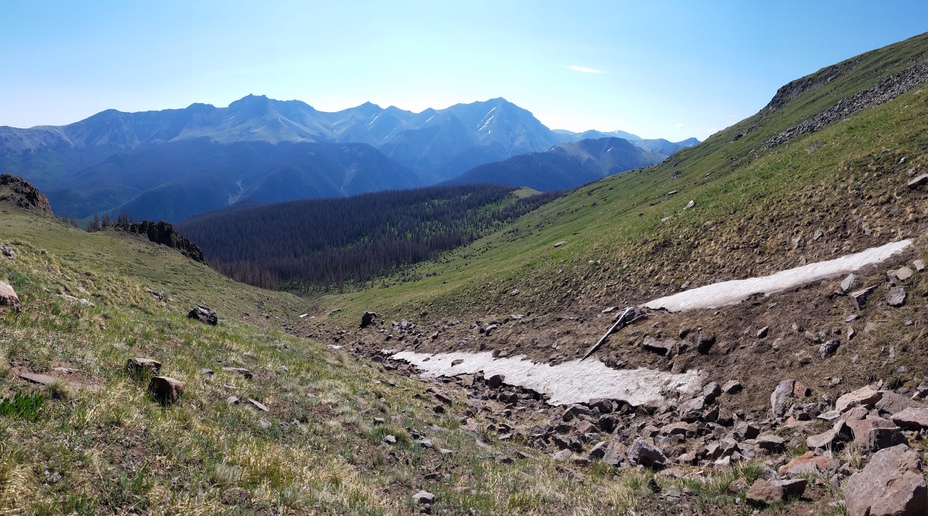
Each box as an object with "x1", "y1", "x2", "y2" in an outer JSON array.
[{"x1": 644, "y1": 240, "x2": 912, "y2": 312}]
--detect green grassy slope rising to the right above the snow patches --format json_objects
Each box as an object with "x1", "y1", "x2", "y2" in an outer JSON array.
[{"x1": 308, "y1": 35, "x2": 928, "y2": 326}]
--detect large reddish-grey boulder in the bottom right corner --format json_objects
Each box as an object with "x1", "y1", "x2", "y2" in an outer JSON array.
[{"x1": 844, "y1": 444, "x2": 928, "y2": 516}]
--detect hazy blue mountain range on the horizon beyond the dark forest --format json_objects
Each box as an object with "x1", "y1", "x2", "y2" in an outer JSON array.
[{"x1": 0, "y1": 95, "x2": 698, "y2": 220}]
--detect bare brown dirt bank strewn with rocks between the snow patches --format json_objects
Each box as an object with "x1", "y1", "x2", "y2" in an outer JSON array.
[{"x1": 304, "y1": 236, "x2": 928, "y2": 417}]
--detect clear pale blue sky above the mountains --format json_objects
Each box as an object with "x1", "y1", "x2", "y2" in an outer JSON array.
[{"x1": 0, "y1": 0, "x2": 928, "y2": 141}]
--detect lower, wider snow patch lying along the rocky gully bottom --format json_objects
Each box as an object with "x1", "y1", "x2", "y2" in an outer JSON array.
[{"x1": 393, "y1": 351, "x2": 702, "y2": 406}]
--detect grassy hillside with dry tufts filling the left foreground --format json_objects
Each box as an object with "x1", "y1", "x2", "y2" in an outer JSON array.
[{"x1": 0, "y1": 205, "x2": 772, "y2": 514}]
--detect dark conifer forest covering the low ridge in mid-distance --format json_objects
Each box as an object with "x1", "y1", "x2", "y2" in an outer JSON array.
[{"x1": 176, "y1": 185, "x2": 561, "y2": 291}]
